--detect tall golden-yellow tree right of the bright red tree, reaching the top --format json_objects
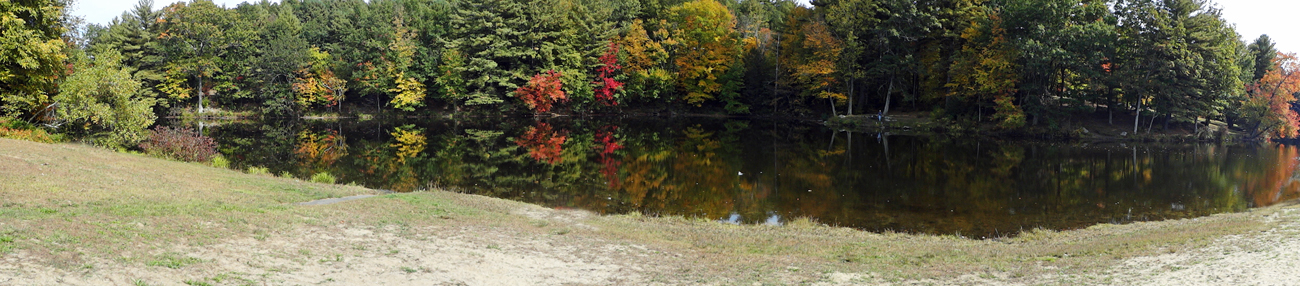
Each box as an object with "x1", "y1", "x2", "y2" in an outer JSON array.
[{"x1": 670, "y1": 0, "x2": 742, "y2": 107}]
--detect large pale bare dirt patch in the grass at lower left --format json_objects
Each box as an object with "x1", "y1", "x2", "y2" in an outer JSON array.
[{"x1": 0, "y1": 226, "x2": 666, "y2": 285}]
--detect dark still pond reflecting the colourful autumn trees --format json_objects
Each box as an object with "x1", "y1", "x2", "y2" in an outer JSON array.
[{"x1": 183, "y1": 118, "x2": 1300, "y2": 238}]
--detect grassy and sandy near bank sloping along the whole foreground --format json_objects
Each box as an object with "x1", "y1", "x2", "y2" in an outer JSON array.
[{"x1": 0, "y1": 139, "x2": 1300, "y2": 285}]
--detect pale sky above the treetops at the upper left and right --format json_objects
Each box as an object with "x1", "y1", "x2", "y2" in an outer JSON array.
[{"x1": 73, "y1": 0, "x2": 1300, "y2": 52}]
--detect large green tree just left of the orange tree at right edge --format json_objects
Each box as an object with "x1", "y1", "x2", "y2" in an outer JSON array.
[{"x1": 1117, "y1": 0, "x2": 1244, "y2": 133}]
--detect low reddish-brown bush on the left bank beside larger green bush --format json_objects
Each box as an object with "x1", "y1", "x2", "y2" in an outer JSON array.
[{"x1": 140, "y1": 126, "x2": 217, "y2": 163}]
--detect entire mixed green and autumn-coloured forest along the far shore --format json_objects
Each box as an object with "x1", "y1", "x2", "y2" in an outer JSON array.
[{"x1": 0, "y1": 0, "x2": 1300, "y2": 146}]
